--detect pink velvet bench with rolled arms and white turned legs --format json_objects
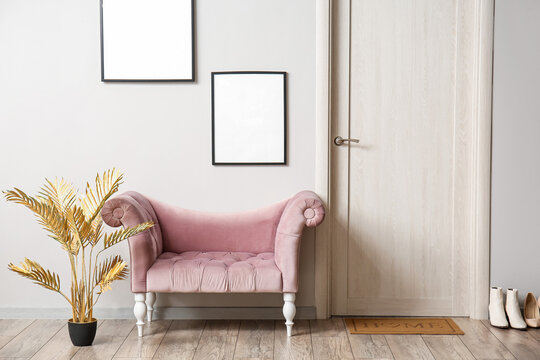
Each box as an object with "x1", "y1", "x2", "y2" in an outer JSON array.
[{"x1": 101, "y1": 191, "x2": 324, "y2": 336}]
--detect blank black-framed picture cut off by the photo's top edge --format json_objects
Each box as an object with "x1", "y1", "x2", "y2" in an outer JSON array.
[{"x1": 100, "y1": 0, "x2": 195, "y2": 81}]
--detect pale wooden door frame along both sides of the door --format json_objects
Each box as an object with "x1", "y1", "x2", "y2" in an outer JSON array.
[{"x1": 315, "y1": 0, "x2": 494, "y2": 319}]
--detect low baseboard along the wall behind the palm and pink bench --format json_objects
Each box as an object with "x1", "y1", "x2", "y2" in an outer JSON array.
[{"x1": 0, "y1": 306, "x2": 317, "y2": 320}]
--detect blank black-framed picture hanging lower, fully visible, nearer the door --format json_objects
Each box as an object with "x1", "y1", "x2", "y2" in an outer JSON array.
[{"x1": 212, "y1": 71, "x2": 287, "y2": 165}]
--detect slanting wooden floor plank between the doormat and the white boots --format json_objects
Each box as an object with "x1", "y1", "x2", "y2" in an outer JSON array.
[{"x1": 454, "y1": 318, "x2": 515, "y2": 360}]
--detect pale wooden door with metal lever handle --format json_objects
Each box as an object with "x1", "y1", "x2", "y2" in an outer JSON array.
[{"x1": 331, "y1": 0, "x2": 486, "y2": 316}]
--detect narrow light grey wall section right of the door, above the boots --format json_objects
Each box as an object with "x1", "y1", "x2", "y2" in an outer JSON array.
[{"x1": 491, "y1": 0, "x2": 540, "y2": 297}]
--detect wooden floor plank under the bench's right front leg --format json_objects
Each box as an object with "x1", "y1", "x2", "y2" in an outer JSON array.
[{"x1": 274, "y1": 320, "x2": 313, "y2": 360}]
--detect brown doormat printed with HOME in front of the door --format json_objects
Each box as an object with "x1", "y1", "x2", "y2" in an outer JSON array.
[{"x1": 345, "y1": 318, "x2": 465, "y2": 335}]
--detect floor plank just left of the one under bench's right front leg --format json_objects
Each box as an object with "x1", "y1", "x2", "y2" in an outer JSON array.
[{"x1": 234, "y1": 320, "x2": 274, "y2": 359}]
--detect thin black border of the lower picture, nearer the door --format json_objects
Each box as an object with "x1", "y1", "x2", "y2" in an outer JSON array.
[{"x1": 211, "y1": 71, "x2": 288, "y2": 166}]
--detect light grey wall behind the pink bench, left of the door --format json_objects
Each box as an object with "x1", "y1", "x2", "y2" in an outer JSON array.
[{"x1": 0, "y1": 0, "x2": 315, "y2": 309}]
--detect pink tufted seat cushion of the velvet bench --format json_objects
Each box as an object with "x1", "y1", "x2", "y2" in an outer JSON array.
[{"x1": 147, "y1": 251, "x2": 283, "y2": 293}]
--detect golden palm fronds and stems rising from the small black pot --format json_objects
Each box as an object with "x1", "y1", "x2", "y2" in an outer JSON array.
[{"x1": 4, "y1": 169, "x2": 154, "y2": 322}]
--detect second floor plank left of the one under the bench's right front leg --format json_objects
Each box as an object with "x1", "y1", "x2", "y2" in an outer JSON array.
[{"x1": 194, "y1": 320, "x2": 240, "y2": 360}]
